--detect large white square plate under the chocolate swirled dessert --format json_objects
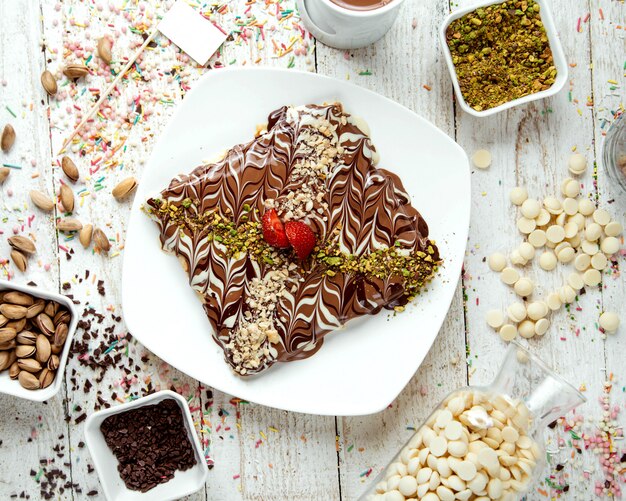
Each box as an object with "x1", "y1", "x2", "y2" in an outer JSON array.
[{"x1": 122, "y1": 68, "x2": 470, "y2": 415}]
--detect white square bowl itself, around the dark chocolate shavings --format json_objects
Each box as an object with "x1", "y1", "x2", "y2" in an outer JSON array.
[{"x1": 85, "y1": 390, "x2": 209, "y2": 501}]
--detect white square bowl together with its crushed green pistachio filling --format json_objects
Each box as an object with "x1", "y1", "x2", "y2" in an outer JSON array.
[{"x1": 440, "y1": 0, "x2": 567, "y2": 117}]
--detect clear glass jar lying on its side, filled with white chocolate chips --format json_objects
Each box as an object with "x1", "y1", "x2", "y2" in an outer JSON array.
[{"x1": 360, "y1": 342, "x2": 585, "y2": 501}]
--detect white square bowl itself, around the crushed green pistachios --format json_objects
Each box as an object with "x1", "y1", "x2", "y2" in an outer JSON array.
[{"x1": 439, "y1": 0, "x2": 567, "y2": 117}]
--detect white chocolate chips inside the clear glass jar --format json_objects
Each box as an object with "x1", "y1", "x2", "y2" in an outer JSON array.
[{"x1": 368, "y1": 389, "x2": 541, "y2": 501}]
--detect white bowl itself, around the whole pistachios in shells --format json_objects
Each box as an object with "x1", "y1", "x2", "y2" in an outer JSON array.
[{"x1": 0, "y1": 280, "x2": 78, "y2": 402}]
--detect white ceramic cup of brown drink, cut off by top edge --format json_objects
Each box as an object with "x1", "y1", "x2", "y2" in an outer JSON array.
[{"x1": 297, "y1": 0, "x2": 404, "y2": 49}]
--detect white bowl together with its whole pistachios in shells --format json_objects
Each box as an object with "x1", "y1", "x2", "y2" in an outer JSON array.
[{"x1": 0, "y1": 280, "x2": 78, "y2": 402}]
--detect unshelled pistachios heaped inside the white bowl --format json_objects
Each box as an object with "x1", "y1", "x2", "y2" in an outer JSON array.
[{"x1": 0, "y1": 290, "x2": 71, "y2": 390}]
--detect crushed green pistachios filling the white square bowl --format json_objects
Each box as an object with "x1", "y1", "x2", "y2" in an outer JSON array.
[{"x1": 446, "y1": 0, "x2": 557, "y2": 111}]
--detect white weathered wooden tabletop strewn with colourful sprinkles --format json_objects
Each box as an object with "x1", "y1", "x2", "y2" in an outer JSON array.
[{"x1": 0, "y1": 0, "x2": 626, "y2": 500}]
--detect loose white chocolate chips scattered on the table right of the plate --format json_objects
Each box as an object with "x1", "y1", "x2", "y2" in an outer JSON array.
[{"x1": 486, "y1": 154, "x2": 623, "y2": 341}]
